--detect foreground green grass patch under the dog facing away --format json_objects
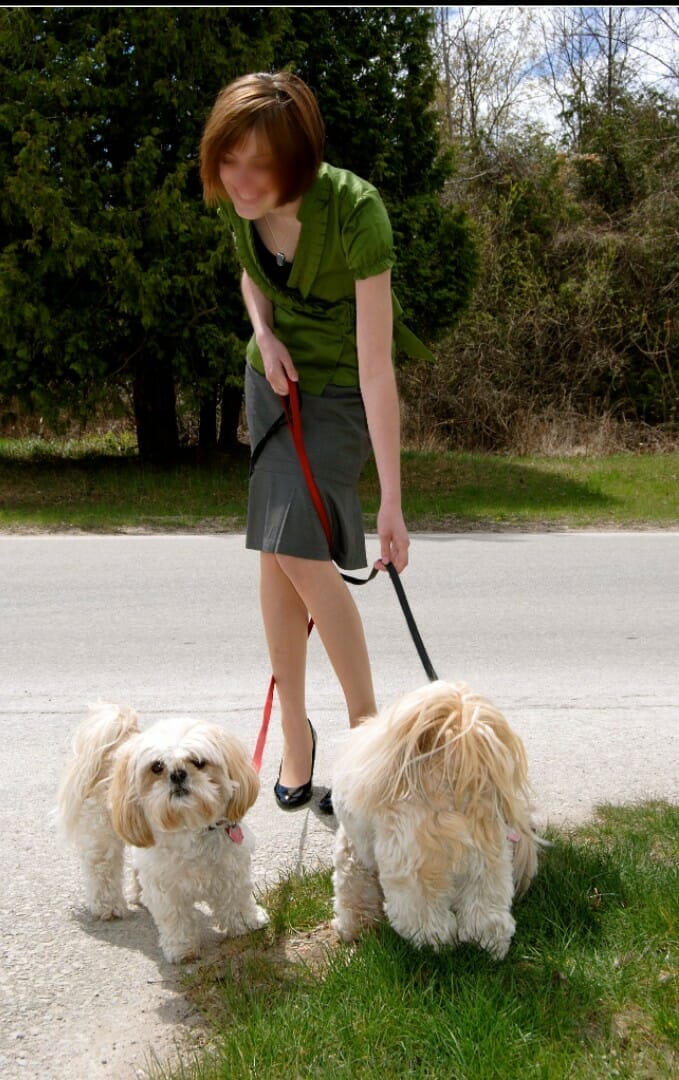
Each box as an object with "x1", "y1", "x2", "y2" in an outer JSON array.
[{"x1": 152, "y1": 801, "x2": 679, "y2": 1080}]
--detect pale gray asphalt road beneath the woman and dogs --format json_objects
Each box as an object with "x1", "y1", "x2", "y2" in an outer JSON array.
[{"x1": 0, "y1": 531, "x2": 679, "y2": 1080}]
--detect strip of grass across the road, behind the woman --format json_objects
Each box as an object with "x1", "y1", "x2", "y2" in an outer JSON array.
[{"x1": 0, "y1": 435, "x2": 679, "y2": 532}]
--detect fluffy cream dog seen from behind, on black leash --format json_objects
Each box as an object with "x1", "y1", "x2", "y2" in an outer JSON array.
[{"x1": 331, "y1": 680, "x2": 544, "y2": 959}]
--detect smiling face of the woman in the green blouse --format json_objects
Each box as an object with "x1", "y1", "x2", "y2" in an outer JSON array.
[{"x1": 219, "y1": 132, "x2": 279, "y2": 221}]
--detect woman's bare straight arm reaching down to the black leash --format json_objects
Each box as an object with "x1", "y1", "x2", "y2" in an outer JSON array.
[{"x1": 356, "y1": 270, "x2": 410, "y2": 573}]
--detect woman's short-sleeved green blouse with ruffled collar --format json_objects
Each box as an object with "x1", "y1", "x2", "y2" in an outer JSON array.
[{"x1": 219, "y1": 163, "x2": 433, "y2": 394}]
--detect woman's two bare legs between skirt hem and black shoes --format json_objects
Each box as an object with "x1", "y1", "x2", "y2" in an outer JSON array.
[{"x1": 260, "y1": 553, "x2": 377, "y2": 787}]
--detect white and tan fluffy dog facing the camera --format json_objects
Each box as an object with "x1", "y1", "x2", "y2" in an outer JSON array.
[{"x1": 57, "y1": 703, "x2": 269, "y2": 963}]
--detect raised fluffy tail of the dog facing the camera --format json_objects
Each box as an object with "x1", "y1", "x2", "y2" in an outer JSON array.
[{"x1": 56, "y1": 701, "x2": 139, "y2": 840}]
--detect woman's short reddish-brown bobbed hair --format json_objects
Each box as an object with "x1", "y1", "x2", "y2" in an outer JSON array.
[{"x1": 200, "y1": 71, "x2": 325, "y2": 205}]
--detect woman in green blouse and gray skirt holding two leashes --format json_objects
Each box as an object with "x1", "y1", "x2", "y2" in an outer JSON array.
[{"x1": 201, "y1": 72, "x2": 426, "y2": 813}]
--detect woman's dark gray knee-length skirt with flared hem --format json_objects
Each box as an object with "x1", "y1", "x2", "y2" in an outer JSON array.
[{"x1": 245, "y1": 363, "x2": 370, "y2": 570}]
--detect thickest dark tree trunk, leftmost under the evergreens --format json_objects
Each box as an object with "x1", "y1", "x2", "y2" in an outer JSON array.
[{"x1": 133, "y1": 353, "x2": 179, "y2": 464}]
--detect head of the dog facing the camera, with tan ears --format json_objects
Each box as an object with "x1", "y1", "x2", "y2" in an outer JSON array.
[{"x1": 109, "y1": 719, "x2": 259, "y2": 848}]
